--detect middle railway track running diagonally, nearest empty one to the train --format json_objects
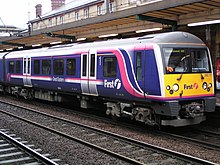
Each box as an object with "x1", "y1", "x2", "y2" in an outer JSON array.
[{"x1": 0, "y1": 100, "x2": 215, "y2": 164}]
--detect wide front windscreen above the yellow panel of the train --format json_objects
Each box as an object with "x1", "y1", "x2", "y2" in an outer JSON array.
[{"x1": 163, "y1": 48, "x2": 211, "y2": 74}]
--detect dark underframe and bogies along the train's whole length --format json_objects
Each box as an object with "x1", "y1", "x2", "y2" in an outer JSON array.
[{"x1": 0, "y1": 85, "x2": 215, "y2": 127}]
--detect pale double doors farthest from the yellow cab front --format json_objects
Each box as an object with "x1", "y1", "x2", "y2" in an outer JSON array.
[{"x1": 23, "y1": 56, "x2": 32, "y2": 87}]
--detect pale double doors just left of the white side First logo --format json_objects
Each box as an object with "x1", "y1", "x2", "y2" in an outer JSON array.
[{"x1": 81, "y1": 49, "x2": 98, "y2": 95}]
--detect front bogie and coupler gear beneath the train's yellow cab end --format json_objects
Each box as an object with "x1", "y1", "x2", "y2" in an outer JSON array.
[{"x1": 106, "y1": 100, "x2": 213, "y2": 127}]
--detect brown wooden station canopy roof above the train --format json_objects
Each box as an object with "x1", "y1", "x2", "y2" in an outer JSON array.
[{"x1": 0, "y1": 0, "x2": 220, "y2": 50}]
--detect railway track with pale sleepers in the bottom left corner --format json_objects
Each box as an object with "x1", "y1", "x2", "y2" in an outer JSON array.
[{"x1": 0, "y1": 129, "x2": 58, "y2": 165}]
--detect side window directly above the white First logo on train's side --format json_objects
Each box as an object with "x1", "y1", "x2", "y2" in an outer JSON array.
[{"x1": 103, "y1": 57, "x2": 117, "y2": 78}]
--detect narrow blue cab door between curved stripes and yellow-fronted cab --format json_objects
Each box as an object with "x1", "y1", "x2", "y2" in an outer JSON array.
[{"x1": 134, "y1": 47, "x2": 146, "y2": 96}]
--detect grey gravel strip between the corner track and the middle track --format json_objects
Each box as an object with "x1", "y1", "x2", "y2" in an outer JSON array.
[{"x1": 0, "y1": 114, "x2": 129, "y2": 165}]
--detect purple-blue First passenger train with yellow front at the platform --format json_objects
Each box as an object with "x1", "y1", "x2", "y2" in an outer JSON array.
[{"x1": 0, "y1": 31, "x2": 216, "y2": 127}]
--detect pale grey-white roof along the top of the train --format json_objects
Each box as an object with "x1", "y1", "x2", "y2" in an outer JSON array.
[{"x1": 3, "y1": 32, "x2": 205, "y2": 59}]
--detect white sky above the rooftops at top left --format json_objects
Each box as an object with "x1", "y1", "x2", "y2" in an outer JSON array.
[{"x1": 0, "y1": 0, "x2": 72, "y2": 28}]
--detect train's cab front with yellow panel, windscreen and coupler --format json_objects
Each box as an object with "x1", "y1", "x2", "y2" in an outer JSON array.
[{"x1": 161, "y1": 47, "x2": 216, "y2": 126}]
